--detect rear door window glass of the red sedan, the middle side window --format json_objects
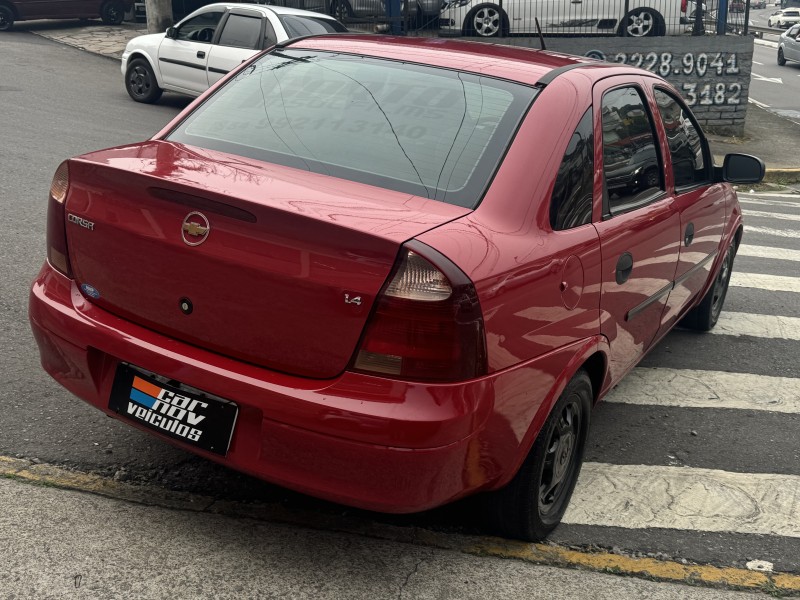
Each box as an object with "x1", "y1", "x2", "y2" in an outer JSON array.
[{"x1": 602, "y1": 87, "x2": 664, "y2": 215}]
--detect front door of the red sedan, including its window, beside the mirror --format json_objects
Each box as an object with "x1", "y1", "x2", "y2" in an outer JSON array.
[{"x1": 653, "y1": 86, "x2": 725, "y2": 328}]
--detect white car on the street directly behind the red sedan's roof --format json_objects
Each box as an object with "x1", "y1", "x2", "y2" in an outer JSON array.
[{"x1": 122, "y1": 3, "x2": 347, "y2": 103}]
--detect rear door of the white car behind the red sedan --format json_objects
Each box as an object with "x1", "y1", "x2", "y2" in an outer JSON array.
[{"x1": 207, "y1": 9, "x2": 270, "y2": 86}]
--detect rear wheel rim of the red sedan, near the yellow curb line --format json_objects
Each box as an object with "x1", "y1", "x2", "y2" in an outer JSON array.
[{"x1": 538, "y1": 397, "x2": 583, "y2": 517}]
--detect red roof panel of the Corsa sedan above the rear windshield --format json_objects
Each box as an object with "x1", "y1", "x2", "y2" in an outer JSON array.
[{"x1": 288, "y1": 34, "x2": 632, "y2": 85}]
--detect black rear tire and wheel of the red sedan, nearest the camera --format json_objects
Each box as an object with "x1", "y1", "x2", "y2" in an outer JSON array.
[{"x1": 486, "y1": 370, "x2": 593, "y2": 542}]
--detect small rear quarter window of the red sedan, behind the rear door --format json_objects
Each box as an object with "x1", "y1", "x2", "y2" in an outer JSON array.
[{"x1": 550, "y1": 108, "x2": 594, "y2": 231}]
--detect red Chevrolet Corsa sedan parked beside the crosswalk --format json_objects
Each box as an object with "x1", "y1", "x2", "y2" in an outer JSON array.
[{"x1": 30, "y1": 36, "x2": 764, "y2": 539}]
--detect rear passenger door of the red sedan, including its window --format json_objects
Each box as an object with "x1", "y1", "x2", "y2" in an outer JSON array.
[{"x1": 594, "y1": 77, "x2": 680, "y2": 379}]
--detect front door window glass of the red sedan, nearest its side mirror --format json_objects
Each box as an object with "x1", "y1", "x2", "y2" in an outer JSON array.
[{"x1": 655, "y1": 89, "x2": 710, "y2": 188}]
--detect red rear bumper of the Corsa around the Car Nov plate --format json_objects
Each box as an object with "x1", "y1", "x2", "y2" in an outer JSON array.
[{"x1": 29, "y1": 263, "x2": 495, "y2": 512}]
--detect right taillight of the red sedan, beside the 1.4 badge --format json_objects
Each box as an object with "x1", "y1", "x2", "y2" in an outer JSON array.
[{"x1": 352, "y1": 241, "x2": 487, "y2": 382}]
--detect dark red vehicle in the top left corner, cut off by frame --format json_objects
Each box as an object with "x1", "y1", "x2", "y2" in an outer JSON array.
[{"x1": 0, "y1": 0, "x2": 133, "y2": 31}]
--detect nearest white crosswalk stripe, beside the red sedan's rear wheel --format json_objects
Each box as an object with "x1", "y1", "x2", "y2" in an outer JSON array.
[{"x1": 564, "y1": 463, "x2": 800, "y2": 538}]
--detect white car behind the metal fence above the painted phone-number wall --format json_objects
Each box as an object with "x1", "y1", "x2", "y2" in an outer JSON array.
[{"x1": 439, "y1": 0, "x2": 694, "y2": 37}]
